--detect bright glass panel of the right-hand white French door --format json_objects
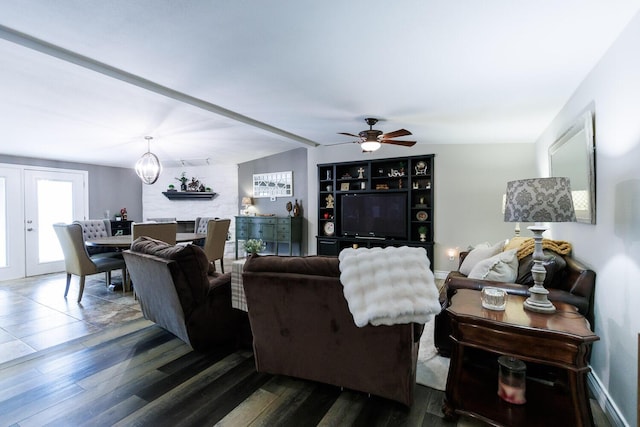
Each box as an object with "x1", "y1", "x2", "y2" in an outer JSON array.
[{"x1": 37, "y1": 179, "x2": 73, "y2": 262}]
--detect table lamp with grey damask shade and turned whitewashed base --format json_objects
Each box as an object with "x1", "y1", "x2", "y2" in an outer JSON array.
[{"x1": 504, "y1": 177, "x2": 576, "y2": 313}]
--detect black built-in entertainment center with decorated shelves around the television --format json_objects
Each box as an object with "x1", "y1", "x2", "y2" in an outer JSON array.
[{"x1": 317, "y1": 154, "x2": 434, "y2": 269}]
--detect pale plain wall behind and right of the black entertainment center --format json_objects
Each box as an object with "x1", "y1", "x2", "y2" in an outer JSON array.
[{"x1": 306, "y1": 142, "x2": 537, "y2": 274}]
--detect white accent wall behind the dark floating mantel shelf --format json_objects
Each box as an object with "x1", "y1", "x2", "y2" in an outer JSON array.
[{"x1": 142, "y1": 164, "x2": 239, "y2": 258}]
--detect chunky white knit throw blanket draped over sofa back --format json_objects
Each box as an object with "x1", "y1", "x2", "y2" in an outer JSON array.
[{"x1": 339, "y1": 246, "x2": 440, "y2": 327}]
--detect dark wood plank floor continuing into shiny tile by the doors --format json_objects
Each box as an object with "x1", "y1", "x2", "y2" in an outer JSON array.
[{"x1": 0, "y1": 275, "x2": 606, "y2": 426}]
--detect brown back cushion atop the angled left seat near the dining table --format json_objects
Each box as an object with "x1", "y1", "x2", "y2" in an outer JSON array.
[{"x1": 131, "y1": 236, "x2": 209, "y2": 319}]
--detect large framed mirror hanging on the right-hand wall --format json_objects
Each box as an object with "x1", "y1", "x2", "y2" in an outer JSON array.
[{"x1": 549, "y1": 110, "x2": 596, "y2": 224}]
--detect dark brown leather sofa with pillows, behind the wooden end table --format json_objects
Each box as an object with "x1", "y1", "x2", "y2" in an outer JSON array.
[{"x1": 434, "y1": 249, "x2": 596, "y2": 357}]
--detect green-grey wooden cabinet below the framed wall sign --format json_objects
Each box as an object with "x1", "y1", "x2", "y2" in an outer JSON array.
[{"x1": 236, "y1": 216, "x2": 302, "y2": 259}]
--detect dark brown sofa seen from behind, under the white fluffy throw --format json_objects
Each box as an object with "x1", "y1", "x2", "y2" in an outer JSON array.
[{"x1": 243, "y1": 255, "x2": 424, "y2": 405}]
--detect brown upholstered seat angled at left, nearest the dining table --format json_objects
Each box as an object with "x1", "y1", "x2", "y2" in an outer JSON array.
[{"x1": 123, "y1": 236, "x2": 248, "y2": 351}]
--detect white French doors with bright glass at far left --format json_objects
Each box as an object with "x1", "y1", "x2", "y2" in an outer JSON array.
[{"x1": 0, "y1": 165, "x2": 88, "y2": 280}]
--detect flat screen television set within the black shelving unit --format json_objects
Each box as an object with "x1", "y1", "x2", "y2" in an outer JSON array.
[{"x1": 340, "y1": 193, "x2": 407, "y2": 239}]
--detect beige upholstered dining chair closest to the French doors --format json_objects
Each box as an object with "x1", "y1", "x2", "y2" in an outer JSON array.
[{"x1": 53, "y1": 224, "x2": 127, "y2": 302}]
